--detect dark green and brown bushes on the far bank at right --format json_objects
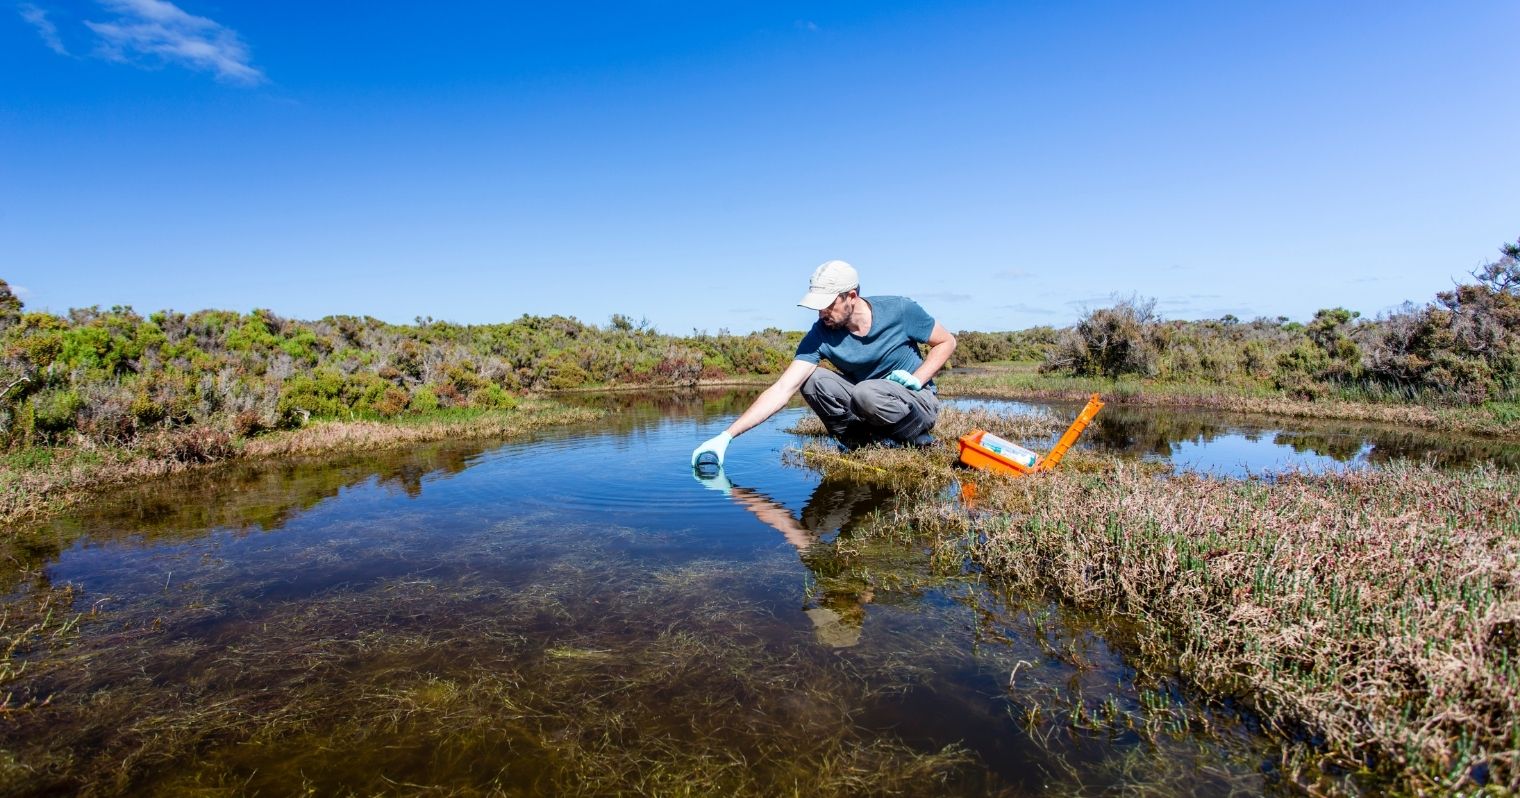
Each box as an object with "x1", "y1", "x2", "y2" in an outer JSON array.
[{"x1": 1041, "y1": 237, "x2": 1520, "y2": 406}]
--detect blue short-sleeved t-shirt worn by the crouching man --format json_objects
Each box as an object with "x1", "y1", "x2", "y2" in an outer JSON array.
[{"x1": 796, "y1": 296, "x2": 935, "y2": 383}]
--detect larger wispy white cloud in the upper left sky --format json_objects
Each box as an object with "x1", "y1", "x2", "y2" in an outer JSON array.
[{"x1": 85, "y1": 0, "x2": 264, "y2": 85}]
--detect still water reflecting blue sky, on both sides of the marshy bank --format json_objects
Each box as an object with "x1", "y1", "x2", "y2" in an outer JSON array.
[{"x1": 0, "y1": 392, "x2": 1515, "y2": 795}]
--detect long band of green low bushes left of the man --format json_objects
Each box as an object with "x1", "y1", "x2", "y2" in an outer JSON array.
[{"x1": 0, "y1": 281, "x2": 800, "y2": 448}]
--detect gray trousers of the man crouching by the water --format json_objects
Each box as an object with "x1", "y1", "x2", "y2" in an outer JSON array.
[{"x1": 803, "y1": 368, "x2": 939, "y2": 442}]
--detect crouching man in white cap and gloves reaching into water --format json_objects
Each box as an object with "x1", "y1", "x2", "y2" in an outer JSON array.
[{"x1": 692, "y1": 260, "x2": 955, "y2": 468}]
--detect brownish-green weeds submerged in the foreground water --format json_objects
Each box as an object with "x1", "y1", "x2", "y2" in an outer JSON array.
[{"x1": 0, "y1": 518, "x2": 974, "y2": 795}]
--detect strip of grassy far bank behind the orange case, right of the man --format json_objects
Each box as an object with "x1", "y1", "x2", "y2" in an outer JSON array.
[{"x1": 938, "y1": 363, "x2": 1520, "y2": 439}]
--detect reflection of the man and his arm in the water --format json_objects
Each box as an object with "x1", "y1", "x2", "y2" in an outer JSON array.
[{"x1": 728, "y1": 482, "x2": 891, "y2": 649}]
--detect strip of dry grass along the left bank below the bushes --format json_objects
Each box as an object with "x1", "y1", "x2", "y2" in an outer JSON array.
[{"x1": 0, "y1": 398, "x2": 600, "y2": 524}]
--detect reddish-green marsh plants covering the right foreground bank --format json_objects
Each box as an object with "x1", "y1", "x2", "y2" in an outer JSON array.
[{"x1": 796, "y1": 415, "x2": 1520, "y2": 793}]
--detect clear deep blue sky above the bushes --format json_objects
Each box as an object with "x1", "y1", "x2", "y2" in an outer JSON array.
[{"x1": 0, "y1": 0, "x2": 1520, "y2": 334}]
